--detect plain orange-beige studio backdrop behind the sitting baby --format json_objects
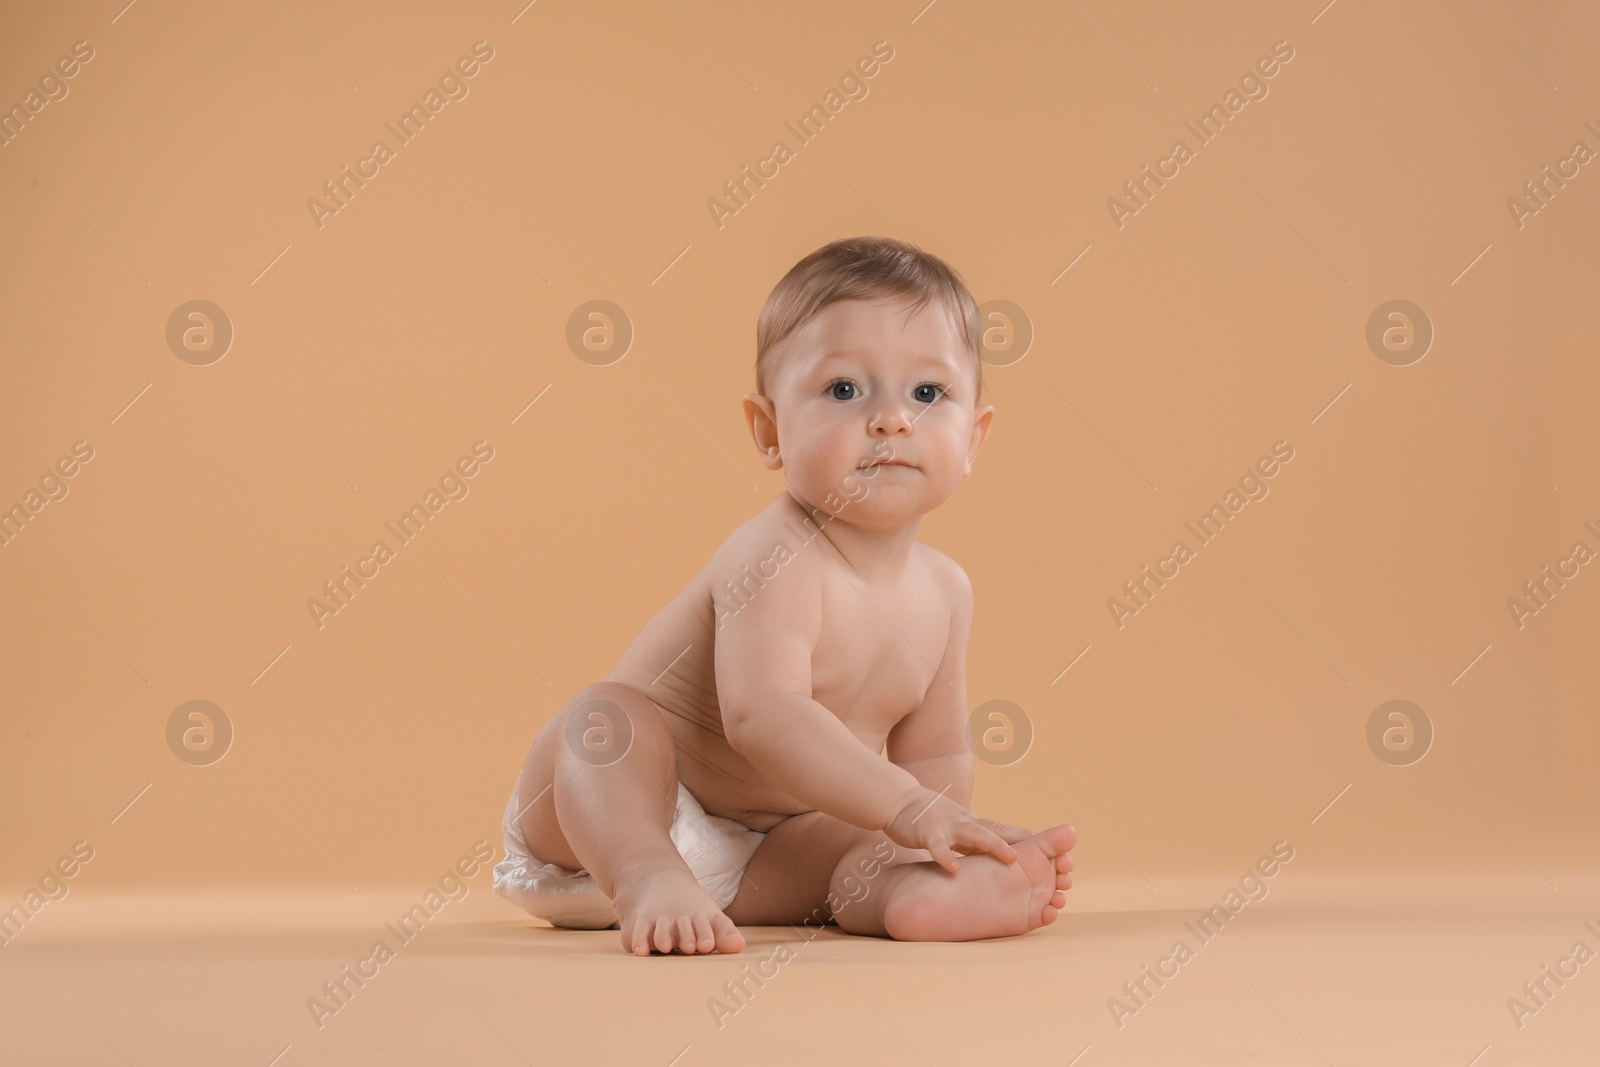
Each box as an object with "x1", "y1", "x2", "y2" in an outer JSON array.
[{"x1": 0, "y1": 0, "x2": 1600, "y2": 1064}]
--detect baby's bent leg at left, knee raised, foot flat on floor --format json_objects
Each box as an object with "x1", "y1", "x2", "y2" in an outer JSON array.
[{"x1": 518, "y1": 681, "x2": 744, "y2": 955}]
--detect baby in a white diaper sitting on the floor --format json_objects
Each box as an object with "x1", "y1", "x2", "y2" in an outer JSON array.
[{"x1": 494, "y1": 237, "x2": 1077, "y2": 955}]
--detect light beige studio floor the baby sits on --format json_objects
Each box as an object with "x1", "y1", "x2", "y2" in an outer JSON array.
[{"x1": 0, "y1": 872, "x2": 1600, "y2": 1067}]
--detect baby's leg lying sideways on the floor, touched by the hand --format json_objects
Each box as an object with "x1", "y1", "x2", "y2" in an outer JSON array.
[{"x1": 728, "y1": 811, "x2": 1077, "y2": 941}]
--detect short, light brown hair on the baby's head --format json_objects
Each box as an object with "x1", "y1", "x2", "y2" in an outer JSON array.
[{"x1": 755, "y1": 237, "x2": 984, "y2": 402}]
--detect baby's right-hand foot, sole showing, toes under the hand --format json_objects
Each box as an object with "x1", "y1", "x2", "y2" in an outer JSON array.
[{"x1": 883, "y1": 824, "x2": 1078, "y2": 941}]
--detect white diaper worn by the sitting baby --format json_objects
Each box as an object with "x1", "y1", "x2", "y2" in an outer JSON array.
[{"x1": 494, "y1": 776, "x2": 766, "y2": 929}]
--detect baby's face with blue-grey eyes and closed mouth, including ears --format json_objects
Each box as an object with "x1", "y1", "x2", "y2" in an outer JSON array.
[{"x1": 747, "y1": 299, "x2": 994, "y2": 528}]
